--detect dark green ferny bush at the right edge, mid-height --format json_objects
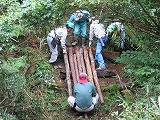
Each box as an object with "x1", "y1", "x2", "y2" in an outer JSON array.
[{"x1": 116, "y1": 48, "x2": 160, "y2": 88}]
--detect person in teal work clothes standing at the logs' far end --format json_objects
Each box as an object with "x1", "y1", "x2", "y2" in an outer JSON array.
[{"x1": 67, "y1": 10, "x2": 90, "y2": 46}]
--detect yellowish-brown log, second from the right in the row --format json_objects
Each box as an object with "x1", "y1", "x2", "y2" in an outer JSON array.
[{"x1": 83, "y1": 47, "x2": 94, "y2": 84}]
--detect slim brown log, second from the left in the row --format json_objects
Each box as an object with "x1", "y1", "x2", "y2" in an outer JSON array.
[{"x1": 68, "y1": 47, "x2": 77, "y2": 84}]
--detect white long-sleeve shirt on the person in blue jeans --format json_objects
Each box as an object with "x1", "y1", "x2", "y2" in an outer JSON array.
[{"x1": 89, "y1": 20, "x2": 106, "y2": 40}]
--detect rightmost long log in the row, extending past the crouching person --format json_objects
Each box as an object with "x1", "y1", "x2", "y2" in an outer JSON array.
[{"x1": 89, "y1": 48, "x2": 104, "y2": 103}]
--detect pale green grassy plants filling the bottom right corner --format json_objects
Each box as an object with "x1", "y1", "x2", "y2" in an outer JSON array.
[{"x1": 112, "y1": 87, "x2": 160, "y2": 120}]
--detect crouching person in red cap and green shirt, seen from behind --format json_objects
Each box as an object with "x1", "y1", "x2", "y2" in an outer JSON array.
[{"x1": 68, "y1": 73, "x2": 99, "y2": 112}]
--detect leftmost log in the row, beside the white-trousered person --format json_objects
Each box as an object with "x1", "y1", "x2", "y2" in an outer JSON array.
[{"x1": 64, "y1": 51, "x2": 72, "y2": 96}]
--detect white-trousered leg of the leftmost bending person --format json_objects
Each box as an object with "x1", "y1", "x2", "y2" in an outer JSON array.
[{"x1": 47, "y1": 37, "x2": 58, "y2": 63}]
